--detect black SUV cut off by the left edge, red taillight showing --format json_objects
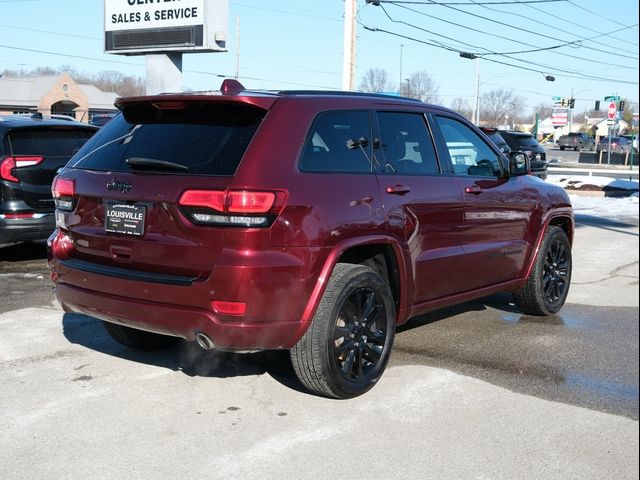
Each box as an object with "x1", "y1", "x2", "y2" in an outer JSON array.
[{"x1": 0, "y1": 115, "x2": 97, "y2": 245}]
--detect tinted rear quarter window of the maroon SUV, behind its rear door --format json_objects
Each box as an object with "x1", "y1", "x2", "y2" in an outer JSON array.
[{"x1": 300, "y1": 110, "x2": 373, "y2": 173}]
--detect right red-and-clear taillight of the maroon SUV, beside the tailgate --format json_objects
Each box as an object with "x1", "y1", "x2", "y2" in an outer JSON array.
[{"x1": 178, "y1": 190, "x2": 287, "y2": 227}]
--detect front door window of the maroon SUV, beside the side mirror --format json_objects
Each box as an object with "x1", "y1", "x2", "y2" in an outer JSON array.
[{"x1": 436, "y1": 116, "x2": 502, "y2": 177}]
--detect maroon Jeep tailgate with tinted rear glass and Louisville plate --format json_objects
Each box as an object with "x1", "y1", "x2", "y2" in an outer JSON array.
[{"x1": 63, "y1": 102, "x2": 266, "y2": 277}]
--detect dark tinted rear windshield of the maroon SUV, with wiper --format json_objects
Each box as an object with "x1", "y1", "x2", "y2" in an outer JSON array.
[{"x1": 69, "y1": 104, "x2": 266, "y2": 176}]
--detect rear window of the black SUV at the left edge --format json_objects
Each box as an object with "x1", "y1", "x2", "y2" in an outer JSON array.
[{"x1": 7, "y1": 127, "x2": 94, "y2": 157}]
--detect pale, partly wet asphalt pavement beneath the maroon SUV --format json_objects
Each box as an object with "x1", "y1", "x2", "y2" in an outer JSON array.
[{"x1": 0, "y1": 211, "x2": 639, "y2": 480}]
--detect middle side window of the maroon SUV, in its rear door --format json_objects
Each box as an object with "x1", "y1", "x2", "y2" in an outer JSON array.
[{"x1": 378, "y1": 112, "x2": 440, "y2": 175}]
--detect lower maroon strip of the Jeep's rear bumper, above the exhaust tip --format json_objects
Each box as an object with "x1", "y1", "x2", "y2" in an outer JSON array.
[{"x1": 55, "y1": 284, "x2": 300, "y2": 350}]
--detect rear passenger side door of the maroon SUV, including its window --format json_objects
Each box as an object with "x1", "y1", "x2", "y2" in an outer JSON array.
[{"x1": 374, "y1": 110, "x2": 464, "y2": 303}]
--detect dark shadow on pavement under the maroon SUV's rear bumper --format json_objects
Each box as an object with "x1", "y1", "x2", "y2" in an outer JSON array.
[{"x1": 62, "y1": 313, "x2": 308, "y2": 393}]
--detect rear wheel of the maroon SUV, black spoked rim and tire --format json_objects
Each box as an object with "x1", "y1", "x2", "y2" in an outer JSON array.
[{"x1": 290, "y1": 263, "x2": 395, "y2": 399}]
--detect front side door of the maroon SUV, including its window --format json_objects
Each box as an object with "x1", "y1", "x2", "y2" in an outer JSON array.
[{"x1": 435, "y1": 113, "x2": 536, "y2": 291}]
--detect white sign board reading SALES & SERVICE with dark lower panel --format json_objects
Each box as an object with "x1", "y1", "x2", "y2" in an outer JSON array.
[{"x1": 104, "y1": 0, "x2": 229, "y2": 55}]
